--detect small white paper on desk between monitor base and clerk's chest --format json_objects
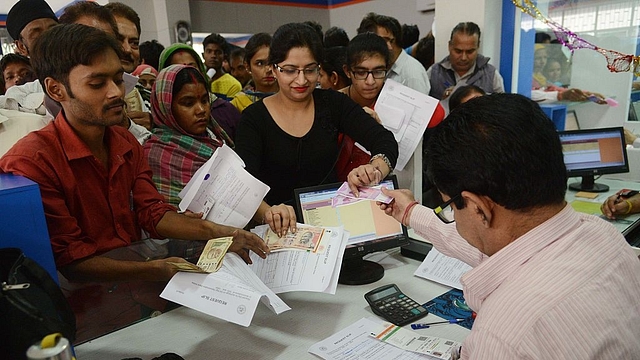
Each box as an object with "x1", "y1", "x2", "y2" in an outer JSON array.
[{"x1": 413, "y1": 248, "x2": 472, "y2": 290}]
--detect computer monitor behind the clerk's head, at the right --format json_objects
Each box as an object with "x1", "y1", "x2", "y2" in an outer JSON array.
[{"x1": 559, "y1": 127, "x2": 629, "y2": 192}]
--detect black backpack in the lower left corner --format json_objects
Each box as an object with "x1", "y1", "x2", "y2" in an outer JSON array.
[{"x1": 0, "y1": 248, "x2": 76, "y2": 359}]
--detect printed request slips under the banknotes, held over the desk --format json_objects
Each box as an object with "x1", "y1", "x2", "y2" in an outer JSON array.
[{"x1": 160, "y1": 224, "x2": 349, "y2": 326}]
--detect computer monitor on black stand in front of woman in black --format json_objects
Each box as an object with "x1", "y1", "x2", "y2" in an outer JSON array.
[{"x1": 294, "y1": 175, "x2": 409, "y2": 285}]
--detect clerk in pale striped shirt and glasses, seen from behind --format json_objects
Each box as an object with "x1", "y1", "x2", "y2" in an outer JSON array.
[{"x1": 380, "y1": 94, "x2": 640, "y2": 360}]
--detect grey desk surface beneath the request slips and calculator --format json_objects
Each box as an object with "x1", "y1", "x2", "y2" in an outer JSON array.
[{"x1": 76, "y1": 249, "x2": 469, "y2": 360}]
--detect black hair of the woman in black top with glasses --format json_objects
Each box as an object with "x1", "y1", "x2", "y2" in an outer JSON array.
[{"x1": 269, "y1": 23, "x2": 324, "y2": 64}]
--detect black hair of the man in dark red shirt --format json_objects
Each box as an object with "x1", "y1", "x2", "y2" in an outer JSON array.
[{"x1": 31, "y1": 24, "x2": 122, "y2": 91}]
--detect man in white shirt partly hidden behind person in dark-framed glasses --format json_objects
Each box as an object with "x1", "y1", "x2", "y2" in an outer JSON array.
[{"x1": 358, "y1": 13, "x2": 430, "y2": 94}]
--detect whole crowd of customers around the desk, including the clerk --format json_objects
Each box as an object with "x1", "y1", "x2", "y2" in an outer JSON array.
[{"x1": 0, "y1": 0, "x2": 640, "y2": 359}]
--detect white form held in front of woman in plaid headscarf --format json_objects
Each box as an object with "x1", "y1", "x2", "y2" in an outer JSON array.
[{"x1": 180, "y1": 145, "x2": 269, "y2": 228}]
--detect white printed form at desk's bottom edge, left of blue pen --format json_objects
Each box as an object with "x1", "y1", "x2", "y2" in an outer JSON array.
[{"x1": 309, "y1": 318, "x2": 434, "y2": 360}]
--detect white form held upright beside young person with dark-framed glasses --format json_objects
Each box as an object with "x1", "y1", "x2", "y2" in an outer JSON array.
[{"x1": 376, "y1": 79, "x2": 438, "y2": 170}]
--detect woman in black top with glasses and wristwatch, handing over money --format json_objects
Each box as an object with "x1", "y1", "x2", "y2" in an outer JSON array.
[{"x1": 236, "y1": 23, "x2": 398, "y2": 227}]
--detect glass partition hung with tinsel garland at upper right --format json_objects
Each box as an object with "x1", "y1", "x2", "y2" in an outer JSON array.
[{"x1": 518, "y1": 0, "x2": 640, "y2": 130}]
